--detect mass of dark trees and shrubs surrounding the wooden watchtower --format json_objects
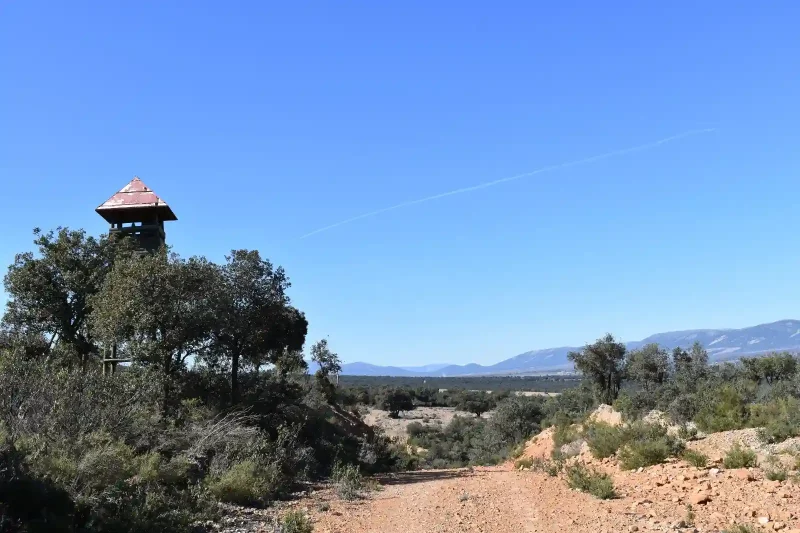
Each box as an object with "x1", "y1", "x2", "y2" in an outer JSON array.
[{"x1": 0, "y1": 229, "x2": 407, "y2": 533}]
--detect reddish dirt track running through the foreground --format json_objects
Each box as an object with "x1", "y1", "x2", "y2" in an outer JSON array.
[{"x1": 315, "y1": 469, "x2": 635, "y2": 533}]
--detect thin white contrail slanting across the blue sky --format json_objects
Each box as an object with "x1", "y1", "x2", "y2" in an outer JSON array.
[{"x1": 300, "y1": 128, "x2": 716, "y2": 239}]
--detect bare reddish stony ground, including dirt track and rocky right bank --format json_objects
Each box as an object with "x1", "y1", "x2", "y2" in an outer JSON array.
[{"x1": 219, "y1": 406, "x2": 800, "y2": 533}]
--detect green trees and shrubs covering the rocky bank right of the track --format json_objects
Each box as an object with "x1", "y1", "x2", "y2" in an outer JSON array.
[{"x1": 408, "y1": 335, "x2": 800, "y2": 478}]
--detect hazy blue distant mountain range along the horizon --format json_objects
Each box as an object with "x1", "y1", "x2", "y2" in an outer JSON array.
[{"x1": 324, "y1": 320, "x2": 800, "y2": 377}]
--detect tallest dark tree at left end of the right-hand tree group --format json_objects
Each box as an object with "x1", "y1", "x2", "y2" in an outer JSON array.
[{"x1": 567, "y1": 333, "x2": 626, "y2": 404}]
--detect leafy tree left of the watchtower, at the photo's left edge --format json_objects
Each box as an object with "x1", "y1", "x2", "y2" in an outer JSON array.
[{"x1": 3, "y1": 228, "x2": 113, "y2": 363}]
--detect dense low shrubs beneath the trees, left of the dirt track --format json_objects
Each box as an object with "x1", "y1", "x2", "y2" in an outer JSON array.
[{"x1": 0, "y1": 352, "x2": 406, "y2": 532}]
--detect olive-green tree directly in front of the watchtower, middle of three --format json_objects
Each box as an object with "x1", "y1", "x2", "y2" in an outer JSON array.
[{"x1": 91, "y1": 250, "x2": 218, "y2": 410}]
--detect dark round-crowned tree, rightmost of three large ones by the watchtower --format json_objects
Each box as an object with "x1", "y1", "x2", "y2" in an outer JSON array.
[{"x1": 207, "y1": 250, "x2": 308, "y2": 405}]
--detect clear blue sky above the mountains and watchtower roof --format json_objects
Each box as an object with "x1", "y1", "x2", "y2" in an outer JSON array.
[{"x1": 0, "y1": 1, "x2": 800, "y2": 364}]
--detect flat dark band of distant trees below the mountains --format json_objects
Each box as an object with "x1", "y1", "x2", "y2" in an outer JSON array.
[{"x1": 339, "y1": 375, "x2": 581, "y2": 392}]
